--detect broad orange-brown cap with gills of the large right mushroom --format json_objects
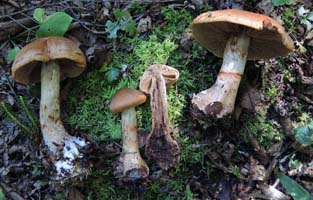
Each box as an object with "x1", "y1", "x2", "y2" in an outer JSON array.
[{"x1": 190, "y1": 9, "x2": 294, "y2": 60}]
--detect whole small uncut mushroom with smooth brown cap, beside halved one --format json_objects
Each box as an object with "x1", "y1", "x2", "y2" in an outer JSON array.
[{"x1": 110, "y1": 88, "x2": 149, "y2": 181}]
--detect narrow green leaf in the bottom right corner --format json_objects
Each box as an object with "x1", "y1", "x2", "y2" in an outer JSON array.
[{"x1": 278, "y1": 173, "x2": 313, "y2": 200}]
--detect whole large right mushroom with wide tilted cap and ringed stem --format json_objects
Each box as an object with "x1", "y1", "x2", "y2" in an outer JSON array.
[{"x1": 190, "y1": 9, "x2": 293, "y2": 119}]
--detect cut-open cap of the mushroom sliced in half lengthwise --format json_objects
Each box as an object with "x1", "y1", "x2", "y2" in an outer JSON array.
[{"x1": 139, "y1": 64, "x2": 179, "y2": 94}]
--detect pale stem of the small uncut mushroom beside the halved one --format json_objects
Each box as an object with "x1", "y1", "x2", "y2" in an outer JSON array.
[{"x1": 122, "y1": 107, "x2": 149, "y2": 180}]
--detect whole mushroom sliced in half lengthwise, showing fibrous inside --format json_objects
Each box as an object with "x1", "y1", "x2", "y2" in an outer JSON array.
[{"x1": 139, "y1": 64, "x2": 180, "y2": 169}]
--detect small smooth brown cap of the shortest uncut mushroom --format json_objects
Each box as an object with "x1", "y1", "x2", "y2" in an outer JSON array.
[{"x1": 110, "y1": 88, "x2": 147, "y2": 113}]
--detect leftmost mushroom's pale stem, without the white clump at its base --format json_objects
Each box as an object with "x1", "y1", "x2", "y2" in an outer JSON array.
[{"x1": 40, "y1": 61, "x2": 70, "y2": 154}]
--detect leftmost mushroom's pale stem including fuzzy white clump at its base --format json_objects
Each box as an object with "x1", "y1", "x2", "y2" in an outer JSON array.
[{"x1": 40, "y1": 61, "x2": 86, "y2": 176}]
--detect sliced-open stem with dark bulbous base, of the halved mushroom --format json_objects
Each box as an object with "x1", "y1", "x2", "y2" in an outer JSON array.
[{"x1": 146, "y1": 70, "x2": 180, "y2": 169}]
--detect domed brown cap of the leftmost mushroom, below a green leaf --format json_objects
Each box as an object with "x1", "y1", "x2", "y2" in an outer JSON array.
[{"x1": 12, "y1": 37, "x2": 86, "y2": 84}]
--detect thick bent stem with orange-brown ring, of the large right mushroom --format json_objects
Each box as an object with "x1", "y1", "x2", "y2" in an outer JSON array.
[{"x1": 192, "y1": 33, "x2": 250, "y2": 118}]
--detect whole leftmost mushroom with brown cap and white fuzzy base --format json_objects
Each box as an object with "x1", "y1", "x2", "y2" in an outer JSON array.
[{"x1": 12, "y1": 37, "x2": 86, "y2": 177}]
